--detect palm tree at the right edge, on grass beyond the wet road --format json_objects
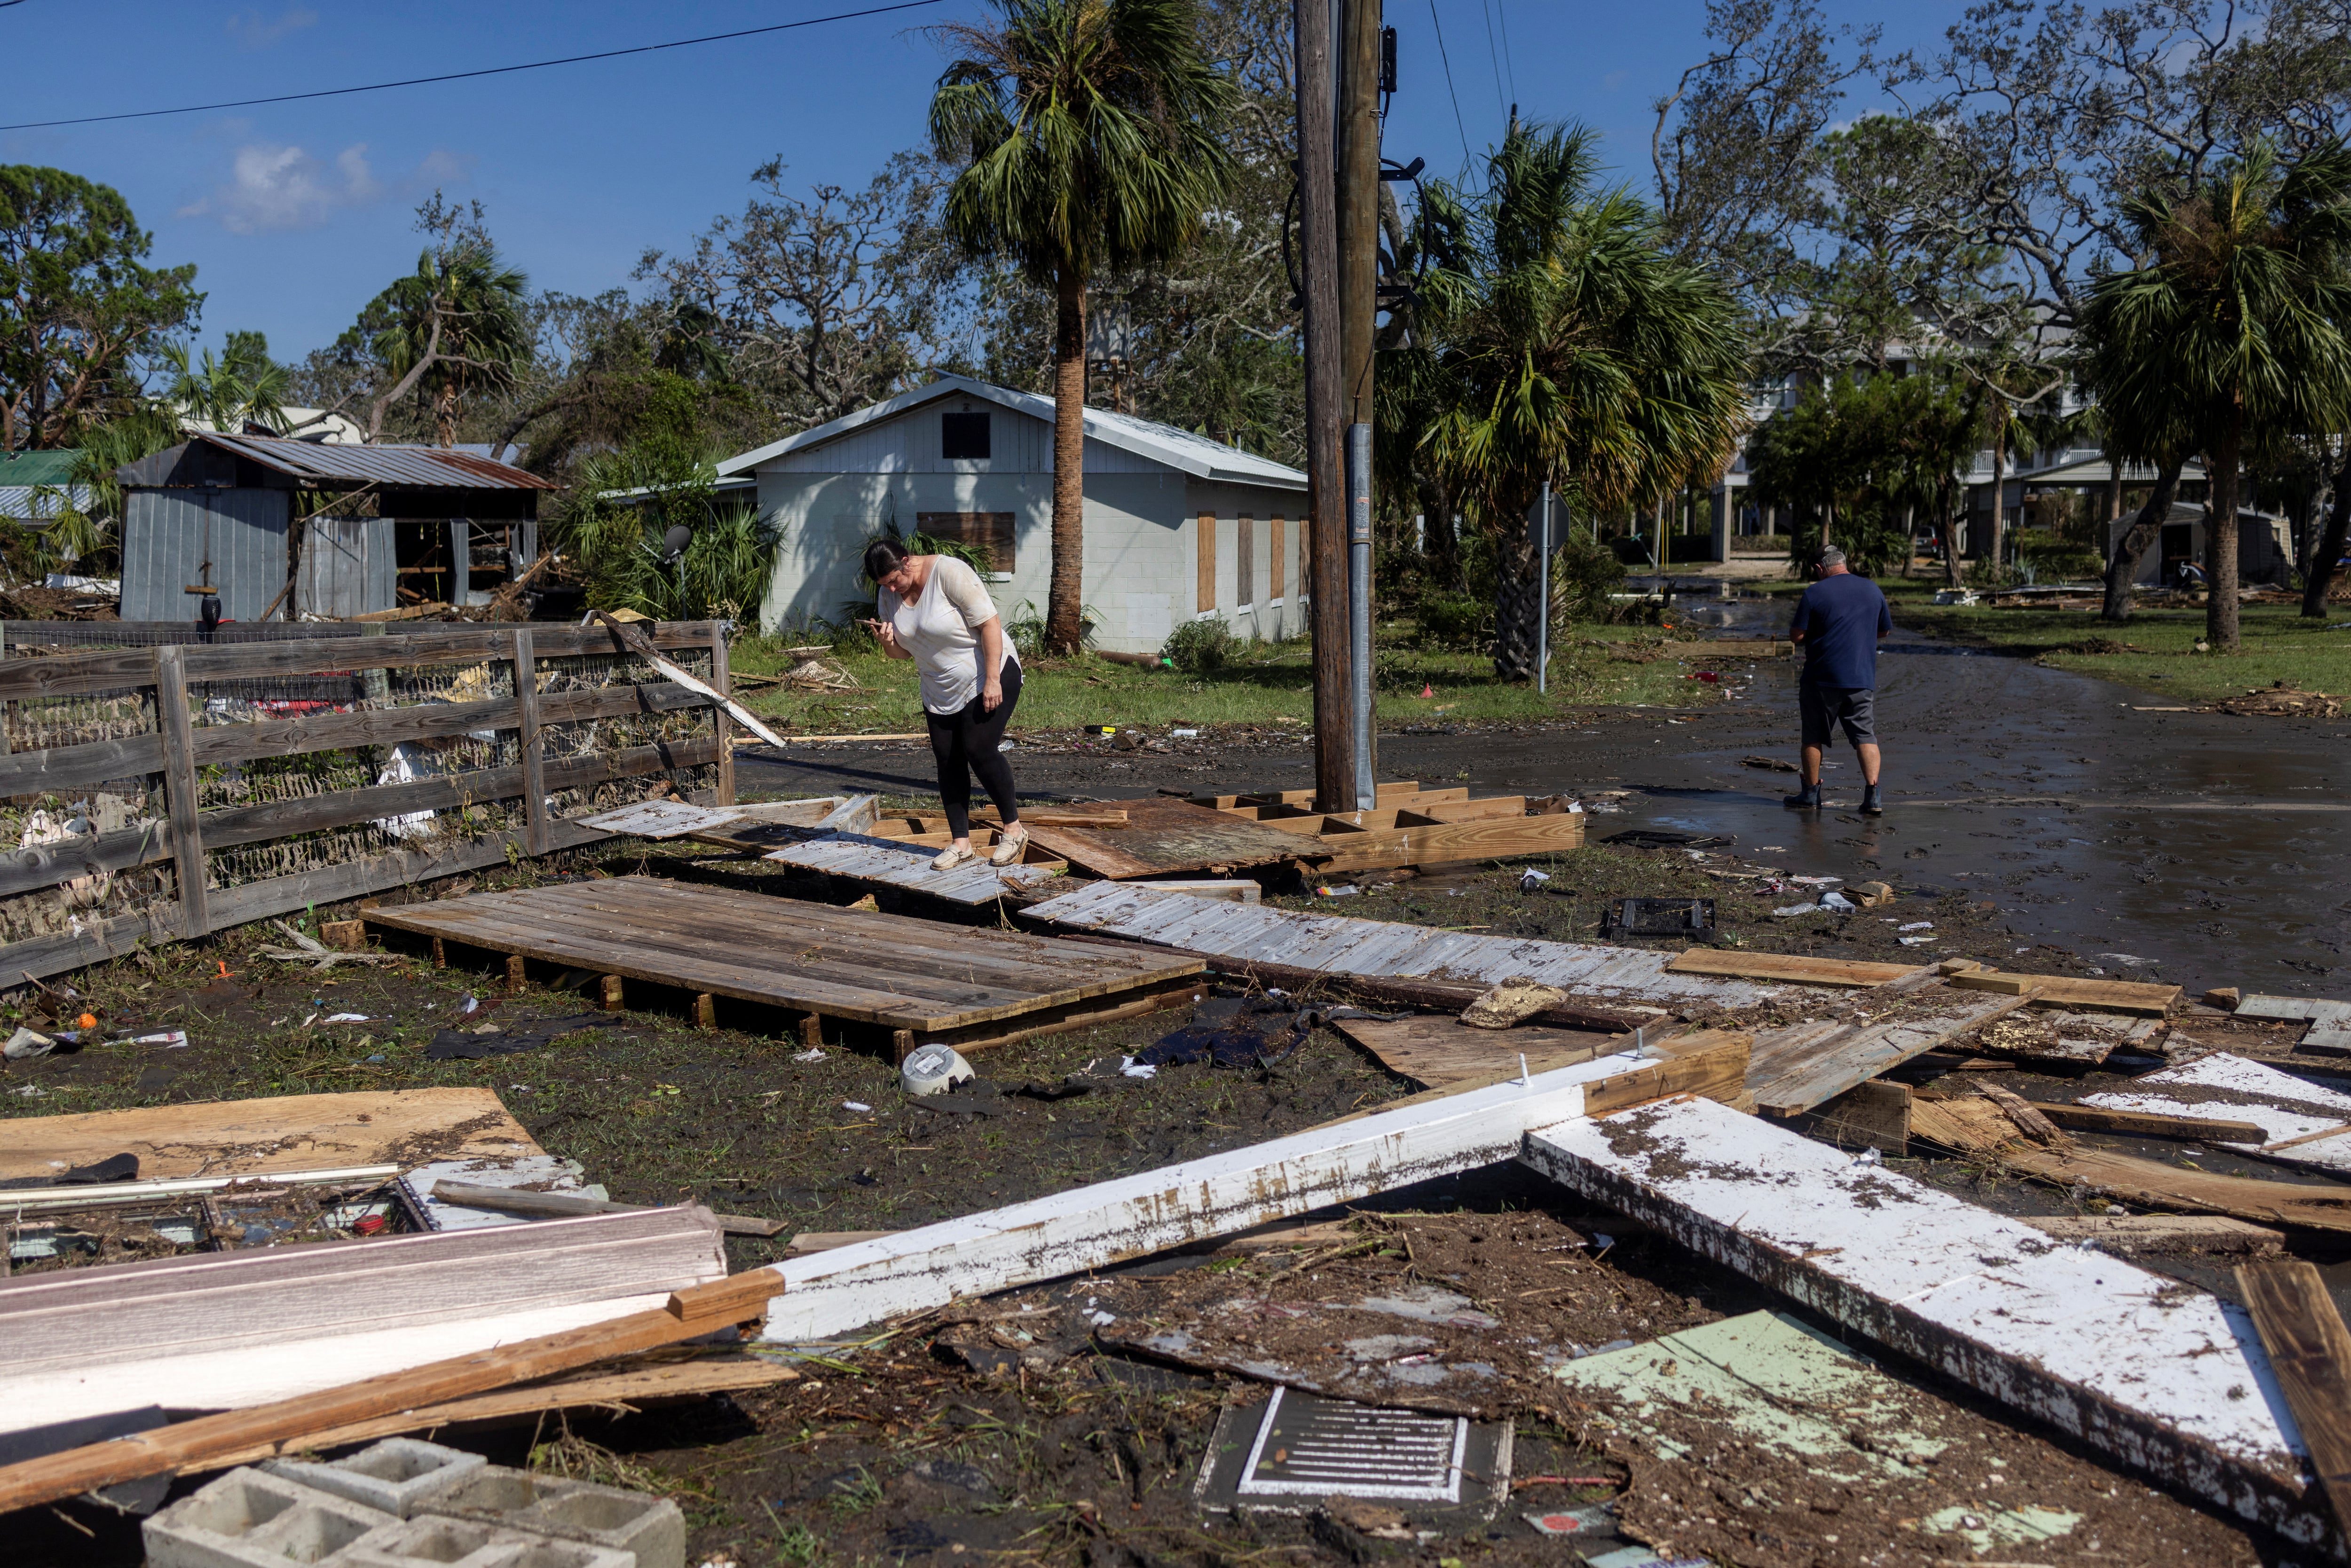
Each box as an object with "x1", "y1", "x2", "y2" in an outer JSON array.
[{"x1": 2088, "y1": 141, "x2": 2351, "y2": 654}]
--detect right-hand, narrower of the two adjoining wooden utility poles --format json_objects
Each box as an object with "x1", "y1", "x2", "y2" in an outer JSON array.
[{"x1": 1338, "y1": 0, "x2": 1380, "y2": 811}]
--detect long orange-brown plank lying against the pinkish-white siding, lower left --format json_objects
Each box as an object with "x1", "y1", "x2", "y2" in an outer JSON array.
[{"x1": 0, "y1": 1281, "x2": 781, "y2": 1512}]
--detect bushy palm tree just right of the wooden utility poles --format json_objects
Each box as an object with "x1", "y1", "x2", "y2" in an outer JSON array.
[{"x1": 1380, "y1": 122, "x2": 1749, "y2": 679}]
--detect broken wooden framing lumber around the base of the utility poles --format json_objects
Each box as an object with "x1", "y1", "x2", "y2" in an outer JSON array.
[{"x1": 1192, "y1": 780, "x2": 1585, "y2": 877}]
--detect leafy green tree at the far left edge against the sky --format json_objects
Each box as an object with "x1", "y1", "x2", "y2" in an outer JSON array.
[{"x1": 0, "y1": 165, "x2": 205, "y2": 451}]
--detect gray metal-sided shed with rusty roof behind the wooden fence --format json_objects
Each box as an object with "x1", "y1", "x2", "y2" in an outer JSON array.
[{"x1": 118, "y1": 433, "x2": 557, "y2": 621}]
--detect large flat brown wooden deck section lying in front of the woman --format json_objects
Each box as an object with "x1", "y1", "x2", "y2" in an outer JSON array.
[{"x1": 367, "y1": 877, "x2": 1201, "y2": 1058}]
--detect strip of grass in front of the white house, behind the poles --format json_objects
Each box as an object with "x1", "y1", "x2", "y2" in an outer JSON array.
[{"x1": 729, "y1": 625, "x2": 1740, "y2": 733}]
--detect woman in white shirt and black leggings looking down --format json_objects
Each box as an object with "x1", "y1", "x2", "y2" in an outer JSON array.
[{"x1": 865, "y1": 538, "x2": 1027, "y2": 870}]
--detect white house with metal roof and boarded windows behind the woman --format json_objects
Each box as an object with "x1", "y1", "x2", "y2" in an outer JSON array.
[{"x1": 719, "y1": 376, "x2": 1307, "y2": 654}]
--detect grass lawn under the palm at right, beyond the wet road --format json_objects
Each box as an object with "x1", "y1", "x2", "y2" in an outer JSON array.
[{"x1": 1886, "y1": 581, "x2": 2351, "y2": 703}]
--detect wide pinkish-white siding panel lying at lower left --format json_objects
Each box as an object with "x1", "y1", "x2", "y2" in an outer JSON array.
[{"x1": 0, "y1": 1206, "x2": 726, "y2": 1429}]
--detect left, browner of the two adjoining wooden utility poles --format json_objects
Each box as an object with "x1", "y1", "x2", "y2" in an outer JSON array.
[{"x1": 1291, "y1": 0, "x2": 1354, "y2": 811}]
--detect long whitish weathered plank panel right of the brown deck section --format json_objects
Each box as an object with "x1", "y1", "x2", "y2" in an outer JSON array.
[{"x1": 1027, "y1": 882, "x2": 1777, "y2": 1009}]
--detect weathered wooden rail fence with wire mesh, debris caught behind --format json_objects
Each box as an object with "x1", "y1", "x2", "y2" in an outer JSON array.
[{"x1": 0, "y1": 621, "x2": 734, "y2": 985}]
